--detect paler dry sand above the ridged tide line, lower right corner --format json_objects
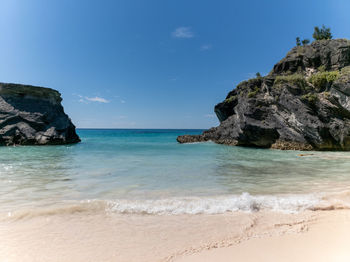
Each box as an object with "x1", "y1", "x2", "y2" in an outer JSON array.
[{"x1": 175, "y1": 211, "x2": 350, "y2": 262}]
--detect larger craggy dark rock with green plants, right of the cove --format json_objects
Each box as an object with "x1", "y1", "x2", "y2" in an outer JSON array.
[{"x1": 177, "y1": 39, "x2": 350, "y2": 150}]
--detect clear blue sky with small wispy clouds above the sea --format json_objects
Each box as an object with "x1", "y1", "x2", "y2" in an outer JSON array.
[{"x1": 0, "y1": 0, "x2": 350, "y2": 128}]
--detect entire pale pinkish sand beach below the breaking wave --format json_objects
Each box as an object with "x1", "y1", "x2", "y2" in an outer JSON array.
[{"x1": 0, "y1": 210, "x2": 350, "y2": 262}]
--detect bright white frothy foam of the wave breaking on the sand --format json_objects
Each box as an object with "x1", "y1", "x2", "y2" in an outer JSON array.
[{"x1": 109, "y1": 193, "x2": 324, "y2": 215}]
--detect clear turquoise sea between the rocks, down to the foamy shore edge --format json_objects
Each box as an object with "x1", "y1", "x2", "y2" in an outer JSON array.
[{"x1": 0, "y1": 129, "x2": 350, "y2": 213}]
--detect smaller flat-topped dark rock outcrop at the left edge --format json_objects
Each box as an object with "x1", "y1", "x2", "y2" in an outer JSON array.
[{"x1": 0, "y1": 83, "x2": 80, "y2": 145}]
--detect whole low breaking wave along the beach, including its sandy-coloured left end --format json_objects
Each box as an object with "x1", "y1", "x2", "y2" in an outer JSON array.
[{"x1": 6, "y1": 192, "x2": 350, "y2": 219}]
